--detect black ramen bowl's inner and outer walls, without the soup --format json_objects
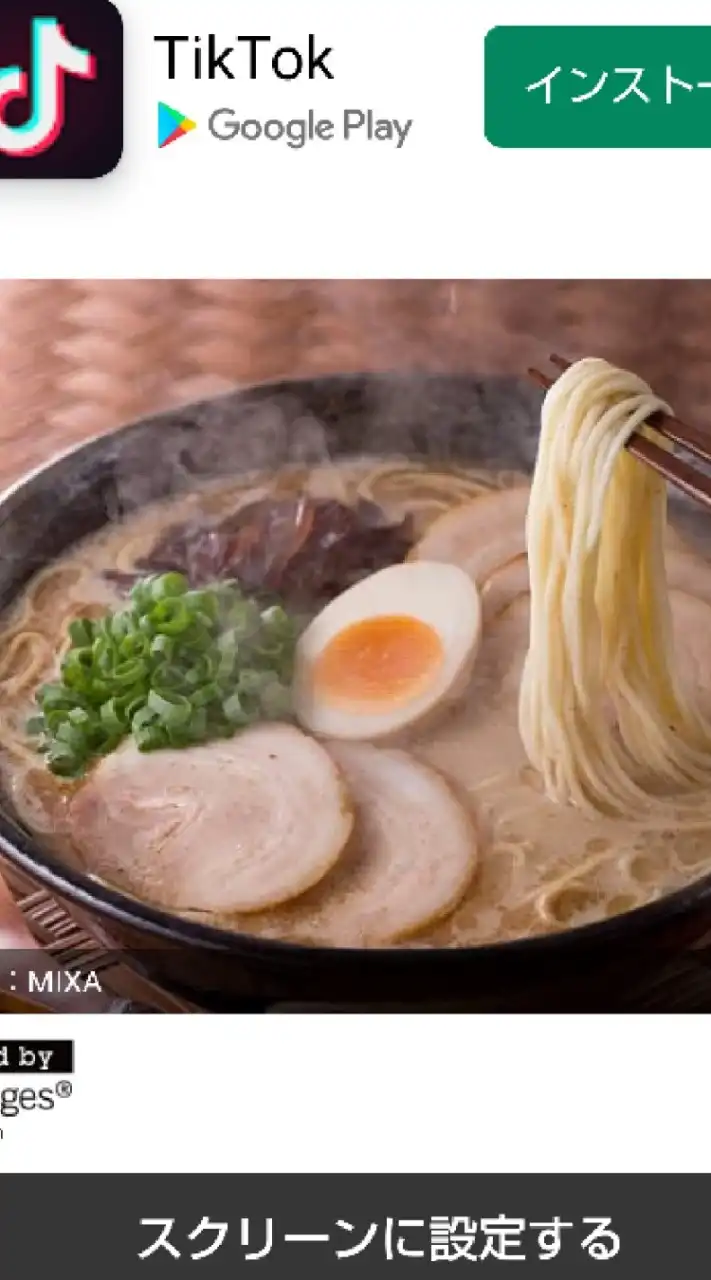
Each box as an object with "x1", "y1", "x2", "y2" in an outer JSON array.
[{"x1": 0, "y1": 374, "x2": 711, "y2": 1011}]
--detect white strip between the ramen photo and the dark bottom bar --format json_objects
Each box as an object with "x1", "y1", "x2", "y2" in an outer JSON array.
[{"x1": 0, "y1": 1014, "x2": 711, "y2": 1172}]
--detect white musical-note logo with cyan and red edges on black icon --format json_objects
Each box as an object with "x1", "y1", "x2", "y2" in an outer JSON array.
[{"x1": 0, "y1": 18, "x2": 96, "y2": 156}]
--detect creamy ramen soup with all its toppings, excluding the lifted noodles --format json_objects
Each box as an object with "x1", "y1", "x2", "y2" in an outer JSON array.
[{"x1": 0, "y1": 458, "x2": 711, "y2": 947}]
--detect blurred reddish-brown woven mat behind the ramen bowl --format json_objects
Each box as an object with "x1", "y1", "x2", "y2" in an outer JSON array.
[{"x1": 0, "y1": 280, "x2": 711, "y2": 486}]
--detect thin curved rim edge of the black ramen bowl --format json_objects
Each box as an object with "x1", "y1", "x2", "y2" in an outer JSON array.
[{"x1": 0, "y1": 370, "x2": 711, "y2": 965}]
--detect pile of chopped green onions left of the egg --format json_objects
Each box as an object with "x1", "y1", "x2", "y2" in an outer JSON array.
[{"x1": 27, "y1": 573, "x2": 297, "y2": 778}]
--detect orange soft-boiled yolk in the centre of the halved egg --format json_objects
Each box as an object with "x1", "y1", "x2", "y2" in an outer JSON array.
[{"x1": 314, "y1": 614, "x2": 445, "y2": 705}]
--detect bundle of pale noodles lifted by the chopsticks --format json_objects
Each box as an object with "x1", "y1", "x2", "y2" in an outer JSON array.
[{"x1": 519, "y1": 360, "x2": 711, "y2": 814}]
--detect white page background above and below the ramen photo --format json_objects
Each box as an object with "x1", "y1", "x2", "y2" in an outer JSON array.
[{"x1": 0, "y1": 0, "x2": 711, "y2": 1171}]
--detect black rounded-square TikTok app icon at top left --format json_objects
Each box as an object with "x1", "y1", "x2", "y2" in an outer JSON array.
[{"x1": 0, "y1": 0, "x2": 123, "y2": 179}]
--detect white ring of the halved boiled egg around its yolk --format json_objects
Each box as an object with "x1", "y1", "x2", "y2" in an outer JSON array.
[{"x1": 293, "y1": 561, "x2": 482, "y2": 740}]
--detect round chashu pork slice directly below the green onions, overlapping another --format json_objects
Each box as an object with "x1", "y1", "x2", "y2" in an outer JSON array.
[{"x1": 69, "y1": 724, "x2": 354, "y2": 915}]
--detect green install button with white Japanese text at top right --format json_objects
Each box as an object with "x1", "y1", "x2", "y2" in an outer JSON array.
[{"x1": 484, "y1": 27, "x2": 711, "y2": 147}]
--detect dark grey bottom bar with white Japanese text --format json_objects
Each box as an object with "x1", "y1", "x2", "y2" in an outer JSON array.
[{"x1": 0, "y1": 1172, "x2": 711, "y2": 1280}]
